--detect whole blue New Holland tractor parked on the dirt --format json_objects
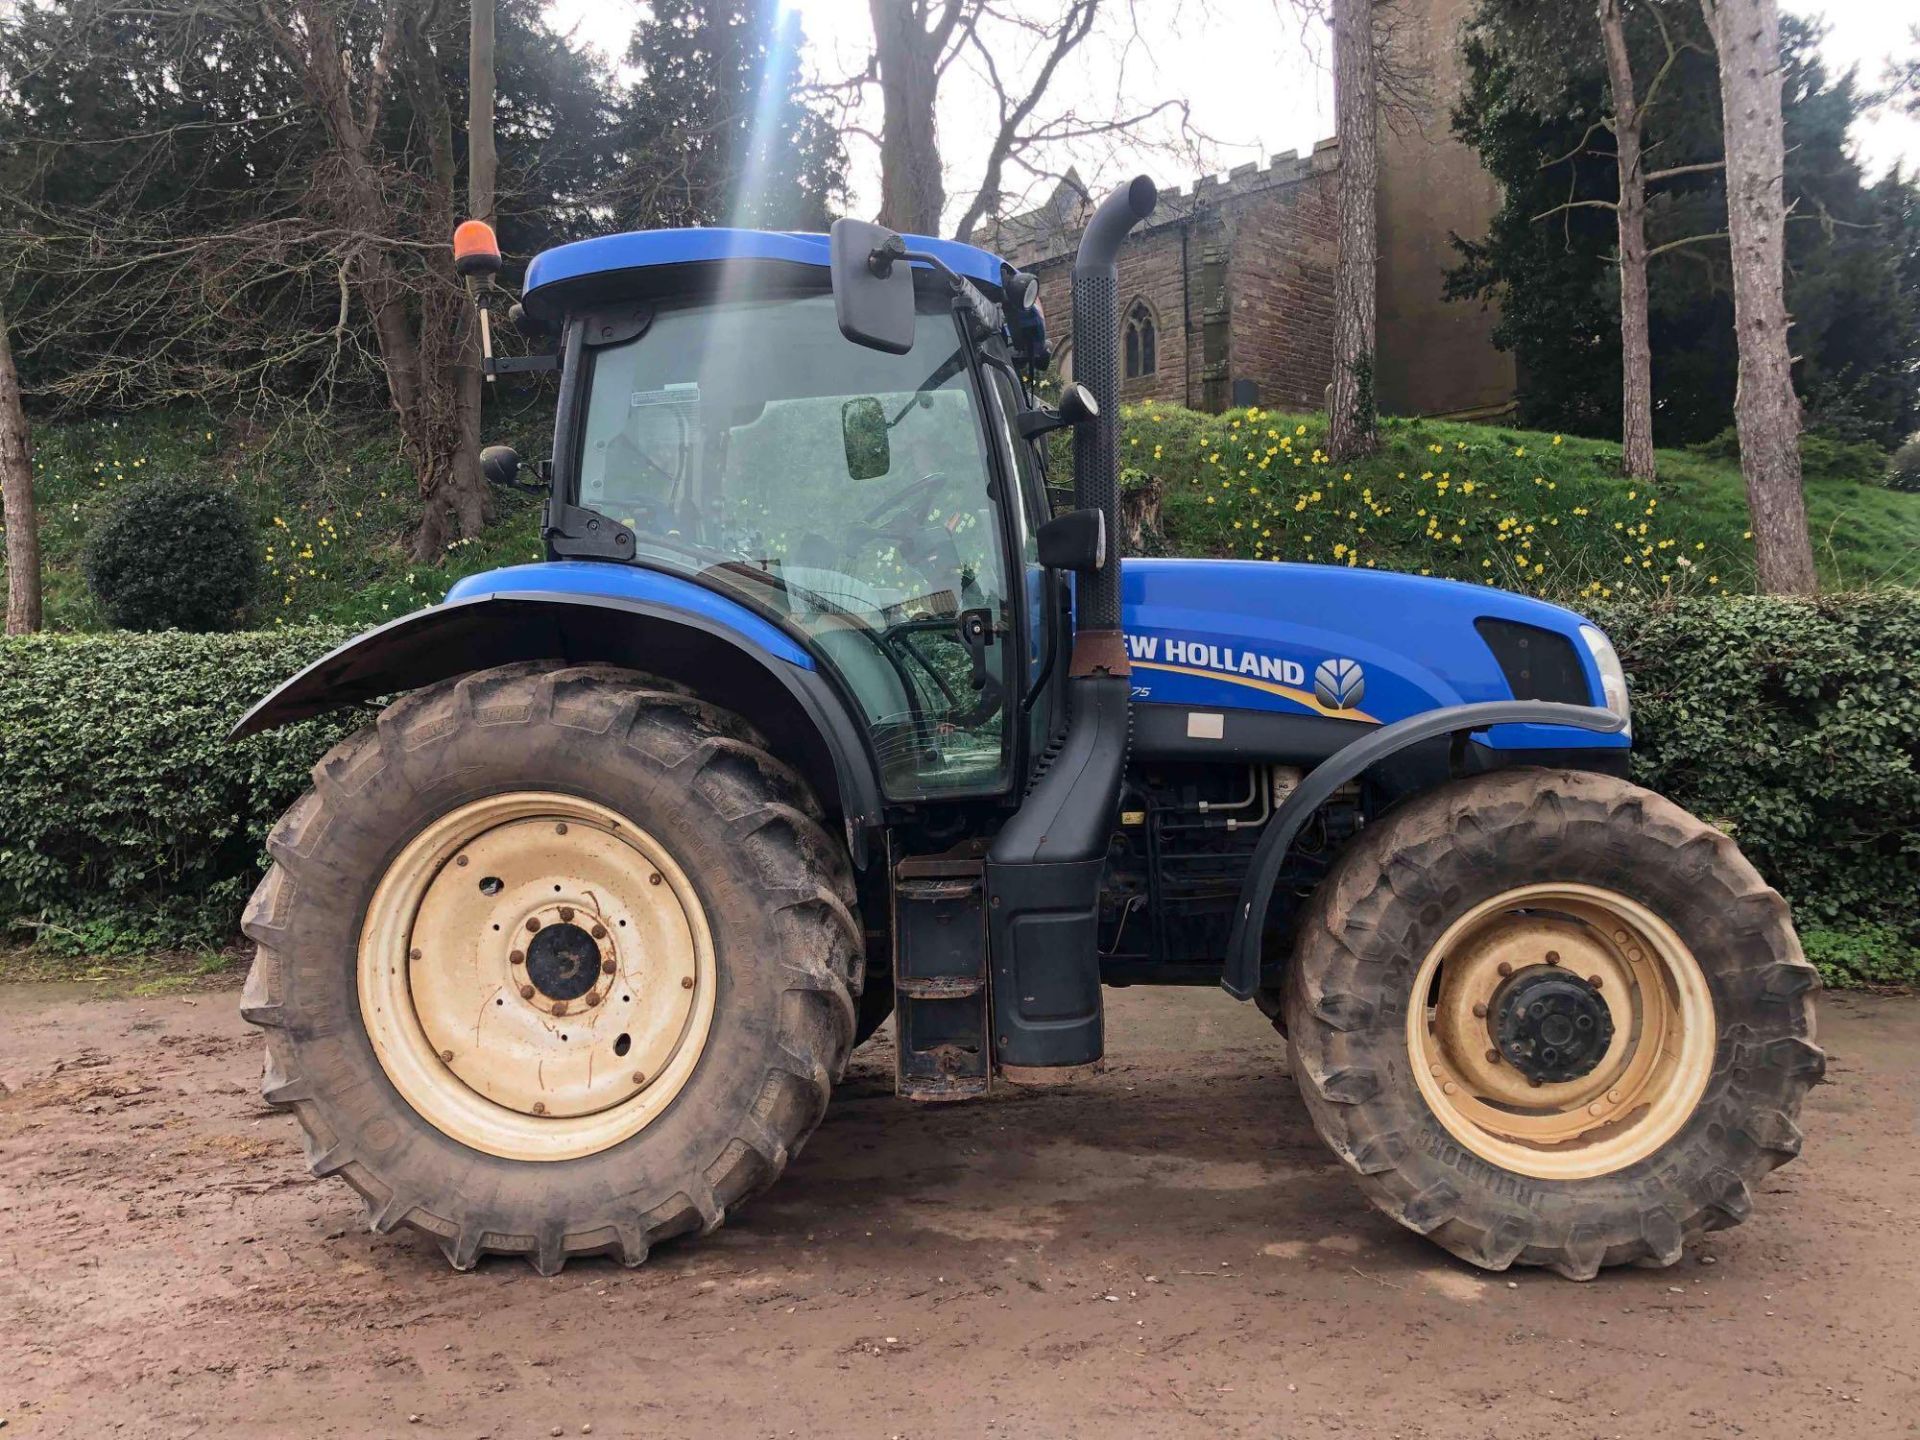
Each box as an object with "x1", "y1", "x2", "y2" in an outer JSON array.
[{"x1": 236, "y1": 179, "x2": 1822, "y2": 1279}]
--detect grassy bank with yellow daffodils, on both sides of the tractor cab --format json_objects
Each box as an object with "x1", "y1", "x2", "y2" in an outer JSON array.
[{"x1": 3, "y1": 403, "x2": 1920, "y2": 630}]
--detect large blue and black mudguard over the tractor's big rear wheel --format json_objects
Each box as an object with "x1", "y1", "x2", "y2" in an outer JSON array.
[{"x1": 228, "y1": 591, "x2": 881, "y2": 864}]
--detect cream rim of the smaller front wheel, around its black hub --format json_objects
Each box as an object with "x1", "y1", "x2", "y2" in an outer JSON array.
[{"x1": 1407, "y1": 885, "x2": 1718, "y2": 1181}]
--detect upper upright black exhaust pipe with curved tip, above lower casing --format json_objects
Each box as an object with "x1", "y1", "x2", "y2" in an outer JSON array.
[{"x1": 1069, "y1": 175, "x2": 1160, "y2": 676}]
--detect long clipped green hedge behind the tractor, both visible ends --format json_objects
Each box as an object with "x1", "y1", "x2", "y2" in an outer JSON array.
[{"x1": 0, "y1": 591, "x2": 1920, "y2": 979}]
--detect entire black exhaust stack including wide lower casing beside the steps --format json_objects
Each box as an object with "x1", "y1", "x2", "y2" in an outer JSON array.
[{"x1": 987, "y1": 175, "x2": 1158, "y2": 1083}]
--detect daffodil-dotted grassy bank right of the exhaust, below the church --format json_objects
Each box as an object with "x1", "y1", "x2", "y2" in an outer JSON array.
[{"x1": 1121, "y1": 405, "x2": 1920, "y2": 599}]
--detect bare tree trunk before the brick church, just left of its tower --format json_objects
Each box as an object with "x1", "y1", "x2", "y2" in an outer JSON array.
[{"x1": 1327, "y1": 0, "x2": 1379, "y2": 461}]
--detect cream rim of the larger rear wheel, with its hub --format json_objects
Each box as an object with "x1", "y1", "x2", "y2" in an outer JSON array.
[{"x1": 359, "y1": 791, "x2": 718, "y2": 1160}]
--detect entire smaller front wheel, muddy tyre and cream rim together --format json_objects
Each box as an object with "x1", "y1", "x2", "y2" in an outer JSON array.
[{"x1": 1283, "y1": 770, "x2": 1824, "y2": 1281}]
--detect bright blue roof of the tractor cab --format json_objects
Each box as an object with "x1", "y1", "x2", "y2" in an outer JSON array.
[{"x1": 522, "y1": 227, "x2": 1004, "y2": 313}]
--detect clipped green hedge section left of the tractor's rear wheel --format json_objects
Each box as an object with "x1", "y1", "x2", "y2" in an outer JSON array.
[{"x1": 0, "y1": 628, "x2": 355, "y2": 952}]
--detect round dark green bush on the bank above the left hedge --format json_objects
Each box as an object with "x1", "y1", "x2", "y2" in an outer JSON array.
[{"x1": 84, "y1": 480, "x2": 259, "y2": 632}]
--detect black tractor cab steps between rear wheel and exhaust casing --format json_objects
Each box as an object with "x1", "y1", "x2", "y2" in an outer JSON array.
[{"x1": 893, "y1": 858, "x2": 993, "y2": 1100}]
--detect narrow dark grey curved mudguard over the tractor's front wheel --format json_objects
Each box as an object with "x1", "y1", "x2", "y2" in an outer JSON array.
[{"x1": 1219, "y1": 701, "x2": 1626, "y2": 1000}]
